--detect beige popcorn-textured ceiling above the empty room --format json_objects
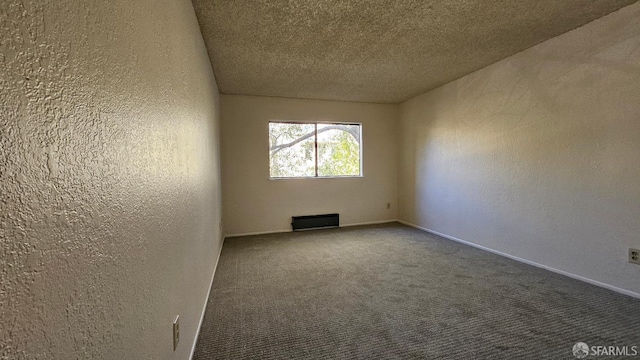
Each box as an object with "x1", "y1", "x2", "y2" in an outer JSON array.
[{"x1": 193, "y1": 0, "x2": 637, "y2": 103}]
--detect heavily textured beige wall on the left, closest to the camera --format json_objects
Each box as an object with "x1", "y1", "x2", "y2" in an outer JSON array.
[{"x1": 0, "y1": 0, "x2": 221, "y2": 359}]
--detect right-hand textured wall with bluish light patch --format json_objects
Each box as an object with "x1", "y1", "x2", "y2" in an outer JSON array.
[{"x1": 398, "y1": 3, "x2": 640, "y2": 293}]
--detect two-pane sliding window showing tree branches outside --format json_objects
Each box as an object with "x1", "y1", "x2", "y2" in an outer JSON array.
[{"x1": 269, "y1": 122, "x2": 362, "y2": 178}]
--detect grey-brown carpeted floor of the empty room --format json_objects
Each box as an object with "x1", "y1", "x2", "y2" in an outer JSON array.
[{"x1": 194, "y1": 223, "x2": 640, "y2": 360}]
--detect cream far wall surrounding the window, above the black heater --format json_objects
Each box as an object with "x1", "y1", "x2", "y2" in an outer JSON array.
[{"x1": 220, "y1": 95, "x2": 398, "y2": 235}]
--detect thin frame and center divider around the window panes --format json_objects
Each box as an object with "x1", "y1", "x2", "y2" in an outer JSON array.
[{"x1": 267, "y1": 120, "x2": 364, "y2": 180}]
